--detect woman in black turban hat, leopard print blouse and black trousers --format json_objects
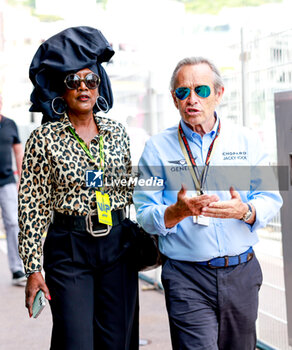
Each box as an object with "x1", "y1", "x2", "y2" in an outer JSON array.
[{"x1": 19, "y1": 27, "x2": 138, "y2": 350}]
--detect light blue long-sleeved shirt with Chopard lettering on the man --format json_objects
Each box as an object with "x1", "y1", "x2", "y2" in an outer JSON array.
[{"x1": 133, "y1": 118, "x2": 282, "y2": 261}]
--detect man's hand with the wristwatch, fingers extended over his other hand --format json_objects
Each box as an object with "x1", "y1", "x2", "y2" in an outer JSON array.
[{"x1": 202, "y1": 187, "x2": 255, "y2": 224}]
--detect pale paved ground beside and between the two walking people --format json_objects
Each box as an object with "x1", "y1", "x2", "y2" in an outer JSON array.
[{"x1": 0, "y1": 238, "x2": 171, "y2": 350}]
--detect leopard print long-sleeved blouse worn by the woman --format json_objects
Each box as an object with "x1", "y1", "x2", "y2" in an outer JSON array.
[{"x1": 19, "y1": 116, "x2": 133, "y2": 273}]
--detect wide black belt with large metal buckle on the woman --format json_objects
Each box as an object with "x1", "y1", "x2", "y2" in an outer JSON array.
[{"x1": 52, "y1": 209, "x2": 126, "y2": 237}]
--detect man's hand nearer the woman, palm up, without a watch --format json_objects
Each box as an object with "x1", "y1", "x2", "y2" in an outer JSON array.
[{"x1": 164, "y1": 185, "x2": 219, "y2": 228}]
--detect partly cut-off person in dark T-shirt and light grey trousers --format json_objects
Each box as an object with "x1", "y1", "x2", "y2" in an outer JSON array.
[{"x1": 0, "y1": 95, "x2": 26, "y2": 286}]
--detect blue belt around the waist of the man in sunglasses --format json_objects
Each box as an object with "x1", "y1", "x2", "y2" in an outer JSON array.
[{"x1": 195, "y1": 247, "x2": 254, "y2": 269}]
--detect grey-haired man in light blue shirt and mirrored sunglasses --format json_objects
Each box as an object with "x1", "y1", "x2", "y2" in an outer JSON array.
[{"x1": 134, "y1": 57, "x2": 282, "y2": 350}]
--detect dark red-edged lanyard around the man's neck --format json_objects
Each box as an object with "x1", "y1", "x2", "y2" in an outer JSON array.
[{"x1": 178, "y1": 120, "x2": 221, "y2": 194}]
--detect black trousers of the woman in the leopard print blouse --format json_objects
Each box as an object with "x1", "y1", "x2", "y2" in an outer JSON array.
[{"x1": 44, "y1": 224, "x2": 139, "y2": 350}]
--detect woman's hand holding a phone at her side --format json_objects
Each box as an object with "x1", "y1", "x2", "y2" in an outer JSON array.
[{"x1": 25, "y1": 272, "x2": 51, "y2": 317}]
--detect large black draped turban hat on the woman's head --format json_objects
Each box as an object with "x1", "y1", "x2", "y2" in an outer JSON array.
[{"x1": 29, "y1": 26, "x2": 115, "y2": 123}]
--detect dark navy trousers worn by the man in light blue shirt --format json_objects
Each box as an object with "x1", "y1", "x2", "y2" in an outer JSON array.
[{"x1": 162, "y1": 256, "x2": 262, "y2": 350}]
